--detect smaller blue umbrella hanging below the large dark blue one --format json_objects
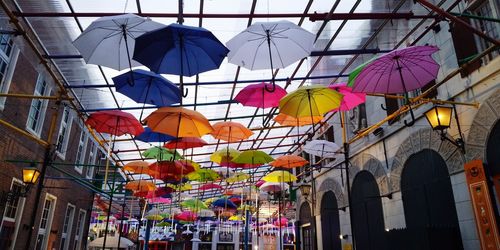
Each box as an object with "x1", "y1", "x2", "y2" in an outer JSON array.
[{"x1": 112, "y1": 69, "x2": 181, "y2": 107}]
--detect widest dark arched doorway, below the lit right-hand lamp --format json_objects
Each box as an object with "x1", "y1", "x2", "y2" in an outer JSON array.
[{"x1": 401, "y1": 149, "x2": 463, "y2": 249}]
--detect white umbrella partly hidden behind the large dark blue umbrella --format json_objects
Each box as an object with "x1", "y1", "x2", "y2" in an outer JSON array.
[{"x1": 73, "y1": 14, "x2": 165, "y2": 70}]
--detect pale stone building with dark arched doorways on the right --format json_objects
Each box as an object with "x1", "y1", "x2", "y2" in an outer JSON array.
[{"x1": 296, "y1": 0, "x2": 500, "y2": 250}]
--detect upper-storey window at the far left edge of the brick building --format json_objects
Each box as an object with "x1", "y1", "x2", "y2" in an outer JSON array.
[{"x1": 0, "y1": 34, "x2": 19, "y2": 109}]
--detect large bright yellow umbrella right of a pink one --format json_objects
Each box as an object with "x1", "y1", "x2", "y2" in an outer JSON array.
[{"x1": 279, "y1": 85, "x2": 343, "y2": 117}]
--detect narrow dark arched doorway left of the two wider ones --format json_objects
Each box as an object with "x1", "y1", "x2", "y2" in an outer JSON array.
[{"x1": 320, "y1": 191, "x2": 342, "y2": 250}]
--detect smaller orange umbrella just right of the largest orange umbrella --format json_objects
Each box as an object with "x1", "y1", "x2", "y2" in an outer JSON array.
[{"x1": 210, "y1": 122, "x2": 253, "y2": 142}]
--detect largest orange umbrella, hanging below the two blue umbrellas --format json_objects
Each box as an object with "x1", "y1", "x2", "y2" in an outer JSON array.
[{"x1": 144, "y1": 107, "x2": 213, "y2": 137}]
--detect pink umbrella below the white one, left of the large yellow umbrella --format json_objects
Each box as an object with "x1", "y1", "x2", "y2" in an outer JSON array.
[{"x1": 234, "y1": 82, "x2": 287, "y2": 108}]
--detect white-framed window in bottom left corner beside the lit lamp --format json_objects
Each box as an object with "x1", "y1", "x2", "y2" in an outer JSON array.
[{"x1": 0, "y1": 179, "x2": 25, "y2": 250}]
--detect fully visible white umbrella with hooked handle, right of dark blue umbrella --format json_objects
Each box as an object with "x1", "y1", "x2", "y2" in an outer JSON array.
[{"x1": 226, "y1": 20, "x2": 315, "y2": 92}]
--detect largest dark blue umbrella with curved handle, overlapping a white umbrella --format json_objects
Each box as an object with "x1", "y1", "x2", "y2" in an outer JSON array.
[{"x1": 134, "y1": 23, "x2": 229, "y2": 93}]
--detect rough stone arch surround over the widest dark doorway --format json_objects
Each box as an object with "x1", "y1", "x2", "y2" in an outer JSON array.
[{"x1": 389, "y1": 128, "x2": 465, "y2": 192}]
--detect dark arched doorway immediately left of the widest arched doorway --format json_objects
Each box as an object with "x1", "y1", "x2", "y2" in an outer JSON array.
[{"x1": 351, "y1": 170, "x2": 387, "y2": 250}]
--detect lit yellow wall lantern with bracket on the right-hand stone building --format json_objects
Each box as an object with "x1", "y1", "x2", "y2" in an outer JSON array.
[{"x1": 425, "y1": 105, "x2": 465, "y2": 154}]
